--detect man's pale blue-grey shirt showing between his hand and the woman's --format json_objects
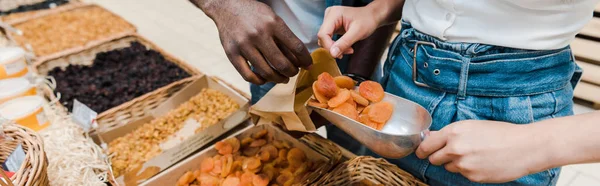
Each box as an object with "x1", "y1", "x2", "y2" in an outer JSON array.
[{"x1": 261, "y1": 0, "x2": 326, "y2": 52}]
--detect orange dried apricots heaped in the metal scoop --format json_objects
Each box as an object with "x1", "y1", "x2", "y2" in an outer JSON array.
[{"x1": 308, "y1": 72, "x2": 394, "y2": 130}]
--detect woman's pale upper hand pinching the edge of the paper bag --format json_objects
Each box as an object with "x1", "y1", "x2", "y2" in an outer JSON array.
[{"x1": 318, "y1": 0, "x2": 404, "y2": 58}]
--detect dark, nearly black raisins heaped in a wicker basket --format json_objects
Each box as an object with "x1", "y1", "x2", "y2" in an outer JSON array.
[{"x1": 48, "y1": 42, "x2": 190, "y2": 113}]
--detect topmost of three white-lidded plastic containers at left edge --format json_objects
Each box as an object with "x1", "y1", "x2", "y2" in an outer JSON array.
[{"x1": 0, "y1": 47, "x2": 29, "y2": 79}]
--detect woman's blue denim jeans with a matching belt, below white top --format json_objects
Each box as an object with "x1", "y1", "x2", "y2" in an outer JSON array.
[{"x1": 382, "y1": 22, "x2": 581, "y2": 185}]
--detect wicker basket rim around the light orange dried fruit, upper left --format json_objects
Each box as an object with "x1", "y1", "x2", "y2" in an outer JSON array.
[{"x1": 4, "y1": 3, "x2": 137, "y2": 62}]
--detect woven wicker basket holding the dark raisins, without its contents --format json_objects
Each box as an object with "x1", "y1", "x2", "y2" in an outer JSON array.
[{"x1": 33, "y1": 34, "x2": 202, "y2": 128}]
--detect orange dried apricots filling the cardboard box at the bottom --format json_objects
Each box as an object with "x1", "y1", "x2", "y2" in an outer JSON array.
[{"x1": 177, "y1": 129, "x2": 319, "y2": 186}]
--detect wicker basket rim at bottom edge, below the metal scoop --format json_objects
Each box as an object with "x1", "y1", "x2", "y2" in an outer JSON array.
[{"x1": 313, "y1": 156, "x2": 427, "y2": 186}]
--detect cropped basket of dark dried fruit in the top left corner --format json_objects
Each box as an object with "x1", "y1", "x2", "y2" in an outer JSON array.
[{"x1": 0, "y1": 0, "x2": 69, "y2": 16}]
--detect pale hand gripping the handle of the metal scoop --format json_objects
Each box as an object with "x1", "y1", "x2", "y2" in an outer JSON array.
[{"x1": 415, "y1": 120, "x2": 548, "y2": 183}]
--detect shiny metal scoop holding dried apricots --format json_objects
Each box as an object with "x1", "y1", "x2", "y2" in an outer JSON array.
[{"x1": 310, "y1": 92, "x2": 431, "y2": 159}]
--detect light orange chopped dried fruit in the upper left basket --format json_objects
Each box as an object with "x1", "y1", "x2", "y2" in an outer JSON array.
[{"x1": 14, "y1": 6, "x2": 134, "y2": 56}]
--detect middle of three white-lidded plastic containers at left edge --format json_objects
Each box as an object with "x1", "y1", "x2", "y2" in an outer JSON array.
[{"x1": 0, "y1": 77, "x2": 37, "y2": 104}]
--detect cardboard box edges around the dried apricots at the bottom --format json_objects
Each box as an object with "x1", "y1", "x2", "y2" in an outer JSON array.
[{"x1": 142, "y1": 124, "x2": 331, "y2": 186}]
